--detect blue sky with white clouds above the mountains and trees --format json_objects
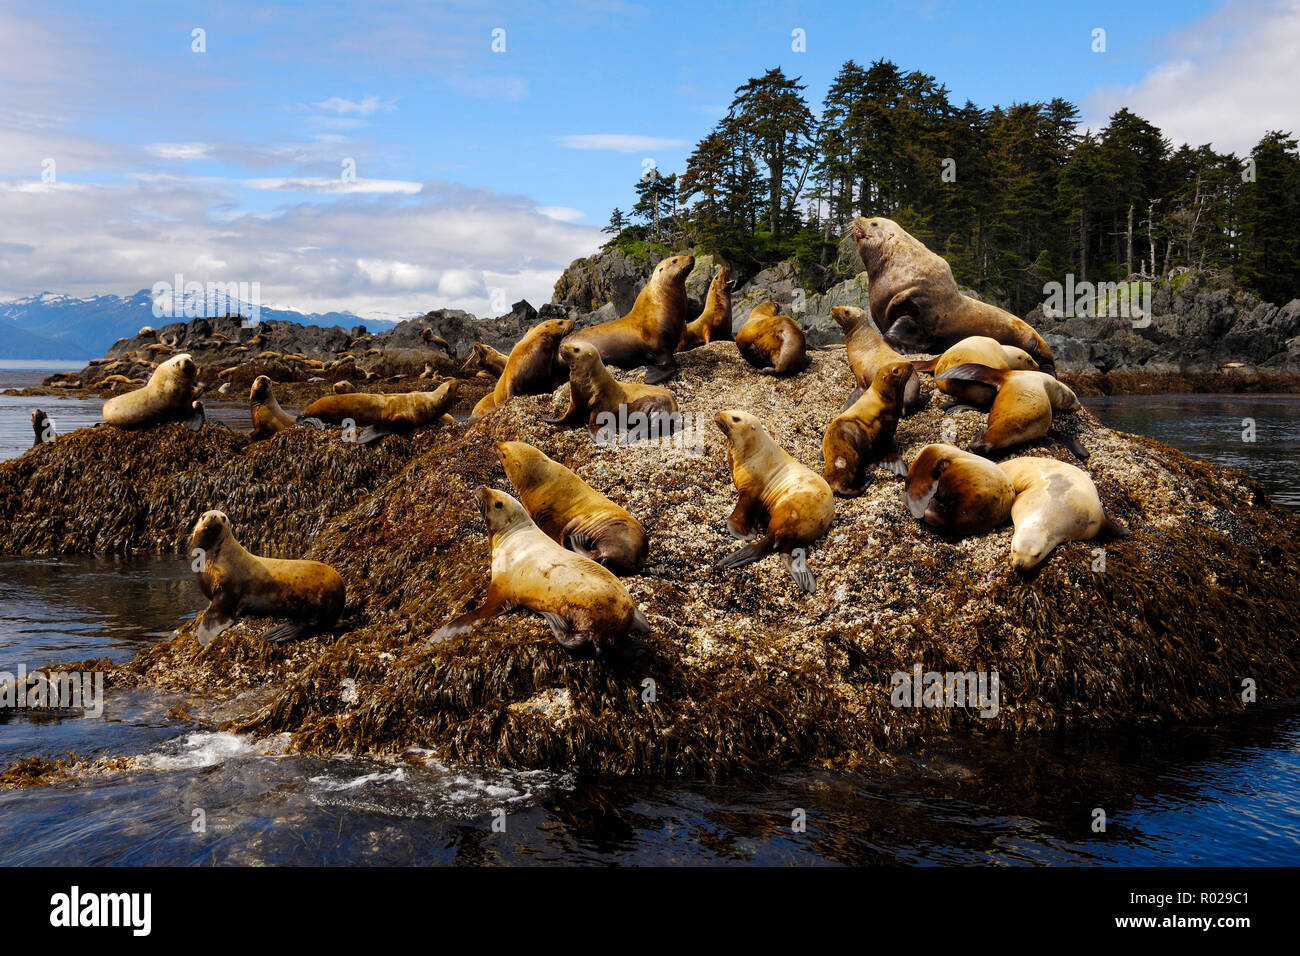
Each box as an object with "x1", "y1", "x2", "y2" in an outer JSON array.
[{"x1": 0, "y1": 0, "x2": 1300, "y2": 321}]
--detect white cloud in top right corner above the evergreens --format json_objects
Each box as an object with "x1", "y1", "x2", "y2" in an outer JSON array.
[{"x1": 1083, "y1": 0, "x2": 1300, "y2": 156}]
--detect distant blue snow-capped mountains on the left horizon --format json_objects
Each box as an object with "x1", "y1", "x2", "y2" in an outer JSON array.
[{"x1": 0, "y1": 289, "x2": 399, "y2": 362}]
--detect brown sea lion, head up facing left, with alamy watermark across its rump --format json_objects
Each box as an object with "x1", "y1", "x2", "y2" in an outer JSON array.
[{"x1": 542, "y1": 338, "x2": 677, "y2": 441}]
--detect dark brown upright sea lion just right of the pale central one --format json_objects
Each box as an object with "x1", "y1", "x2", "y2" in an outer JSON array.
[{"x1": 822, "y1": 360, "x2": 917, "y2": 498}]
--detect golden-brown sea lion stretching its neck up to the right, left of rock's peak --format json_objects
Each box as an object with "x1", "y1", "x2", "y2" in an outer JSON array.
[{"x1": 564, "y1": 255, "x2": 696, "y2": 385}]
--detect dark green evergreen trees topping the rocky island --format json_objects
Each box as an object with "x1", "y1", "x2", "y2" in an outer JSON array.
[{"x1": 606, "y1": 60, "x2": 1300, "y2": 312}]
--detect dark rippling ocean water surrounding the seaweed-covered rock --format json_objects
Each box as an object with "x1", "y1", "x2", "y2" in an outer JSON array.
[{"x1": 0, "y1": 372, "x2": 1300, "y2": 865}]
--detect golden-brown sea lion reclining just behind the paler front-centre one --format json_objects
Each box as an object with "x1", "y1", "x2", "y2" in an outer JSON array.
[{"x1": 495, "y1": 441, "x2": 650, "y2": 575}]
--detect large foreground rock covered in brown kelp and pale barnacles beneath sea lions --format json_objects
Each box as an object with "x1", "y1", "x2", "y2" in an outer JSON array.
[{"x1": 0, "y1": 342, "x2": 1300, "y2": 775}]
